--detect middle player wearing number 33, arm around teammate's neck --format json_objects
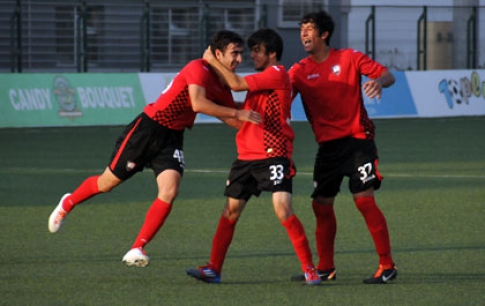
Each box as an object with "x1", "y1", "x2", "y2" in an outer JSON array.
[{"x1": 187, "y1": 29, "x2": 321, "y2": 285}]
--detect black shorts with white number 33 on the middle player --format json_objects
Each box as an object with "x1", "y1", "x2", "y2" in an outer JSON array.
[{"x1": 224, "y1": 157, "x2": 296, "y2": 201}]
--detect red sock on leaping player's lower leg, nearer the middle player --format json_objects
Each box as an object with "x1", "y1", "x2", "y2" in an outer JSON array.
[{"x1": 131, "y1": 198, "x2": 172, "y2": 249}]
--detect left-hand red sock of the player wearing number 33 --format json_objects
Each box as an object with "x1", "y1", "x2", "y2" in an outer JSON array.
[{"x1": 210, "y1": 216, "x2": 237, "y2": 273}]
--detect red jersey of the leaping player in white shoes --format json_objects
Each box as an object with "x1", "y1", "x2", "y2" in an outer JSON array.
[{"x1": 143, "y1": 59, "x2": 236, "y2": 130}]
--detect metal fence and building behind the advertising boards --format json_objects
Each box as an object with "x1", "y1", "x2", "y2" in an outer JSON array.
[{"x1": 0, "y1": 0, "x2": 485, "y2": 73}]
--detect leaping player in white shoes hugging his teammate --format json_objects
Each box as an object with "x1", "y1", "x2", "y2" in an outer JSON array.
[{"x1": 48, "y1": 31, "x2": 261, "y2": 267}]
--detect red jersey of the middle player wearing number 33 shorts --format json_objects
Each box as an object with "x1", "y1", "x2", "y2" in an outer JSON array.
[{"x1": 236, "y1": 66, "x2": 294, "y2": 160}]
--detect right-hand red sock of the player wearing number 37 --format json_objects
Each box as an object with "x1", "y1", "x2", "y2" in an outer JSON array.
[{"x1": 354, "y1": 196, "x2": 393, "y2": 266}]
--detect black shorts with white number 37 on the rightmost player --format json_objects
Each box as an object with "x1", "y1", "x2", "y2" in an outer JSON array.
[{"x1": 312, "y1": 137, "x2": 383, "y2": 198}]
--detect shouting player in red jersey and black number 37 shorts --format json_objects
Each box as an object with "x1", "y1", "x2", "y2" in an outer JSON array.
[{"x1": 289, "y1": 11, "x2": 397, "y2": 284}]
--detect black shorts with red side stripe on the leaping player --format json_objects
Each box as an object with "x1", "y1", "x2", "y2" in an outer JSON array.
[{"x1": 109, "y1": 113, "x2": 185, "y2": 180}]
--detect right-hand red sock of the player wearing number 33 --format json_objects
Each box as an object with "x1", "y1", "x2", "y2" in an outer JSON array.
[{"x1": 281, "y1": 214, "x2": 313, "y2": 271}]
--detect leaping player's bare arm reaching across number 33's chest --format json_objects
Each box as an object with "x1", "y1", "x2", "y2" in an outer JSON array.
[{"x1": 189, "y1": 84, "x2": 261, "y2": 124}]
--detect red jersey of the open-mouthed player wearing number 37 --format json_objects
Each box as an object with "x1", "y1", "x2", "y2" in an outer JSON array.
[{"x1": 289, "y1": 49, "x2": 386, "y2": 143}]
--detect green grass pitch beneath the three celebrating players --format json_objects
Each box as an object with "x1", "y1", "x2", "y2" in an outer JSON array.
[{"x1": 0, "y1": 117, "x2": 485, "y2": 306}]
